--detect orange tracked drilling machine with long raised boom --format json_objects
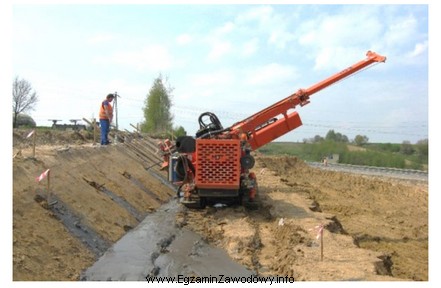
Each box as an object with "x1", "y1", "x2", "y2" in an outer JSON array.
[{"x1": 160, "y1": 51, "x2": 386, "y2": 208}]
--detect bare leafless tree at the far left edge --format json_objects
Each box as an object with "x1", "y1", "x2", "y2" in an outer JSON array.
[{"x1": 12, "y1": 76, "x2": 38, "y2": 128}]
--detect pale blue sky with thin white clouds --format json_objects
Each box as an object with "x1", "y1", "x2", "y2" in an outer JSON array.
[{"x1": 10, "y1": 2, "x2": 429, "y2": 143}]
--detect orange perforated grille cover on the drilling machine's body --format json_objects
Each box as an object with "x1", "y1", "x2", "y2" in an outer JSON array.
[{"x1": 195, "y1": 139, "x2": 241, "y2": 189}]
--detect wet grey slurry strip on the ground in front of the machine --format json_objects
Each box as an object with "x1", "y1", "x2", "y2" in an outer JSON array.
[{"x1": 81, "y1": 199, "x2": 253, "y2": 281}]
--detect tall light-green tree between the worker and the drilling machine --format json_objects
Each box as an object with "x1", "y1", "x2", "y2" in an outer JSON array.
[{"x1": 141, "y1": 75, "x2": 173, "y2": 134}]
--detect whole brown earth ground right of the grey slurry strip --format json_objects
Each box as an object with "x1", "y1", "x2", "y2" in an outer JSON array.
[{"x1": 181, "y1": 156, "x2": 428, "y2": 281}]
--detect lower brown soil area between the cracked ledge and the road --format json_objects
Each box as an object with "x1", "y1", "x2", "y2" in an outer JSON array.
[{"x1": 261, "y1": 158, "x2": 428, "y2": 280}]
